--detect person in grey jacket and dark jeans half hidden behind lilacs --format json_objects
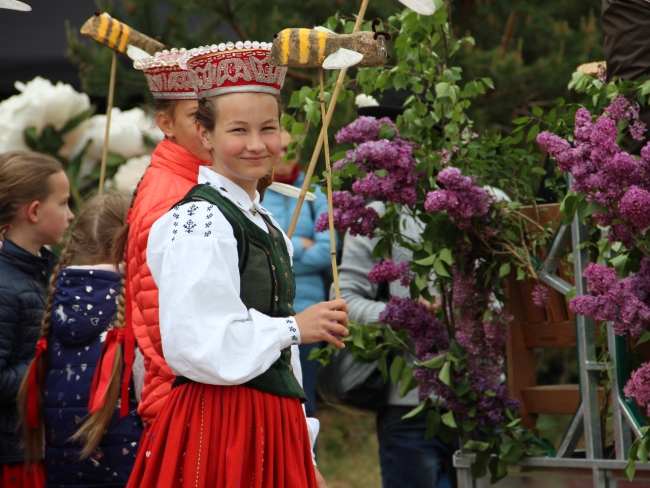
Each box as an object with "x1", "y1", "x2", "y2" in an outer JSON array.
[{"x1": 332, "y1": 202, "x2": 453, "y2": 488}]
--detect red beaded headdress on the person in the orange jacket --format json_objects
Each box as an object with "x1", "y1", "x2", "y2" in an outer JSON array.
[{"x1": 133, "y1": 48, "x2": 196, "y2": 100}]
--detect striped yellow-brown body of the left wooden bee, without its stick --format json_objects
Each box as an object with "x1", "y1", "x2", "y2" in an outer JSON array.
[{"x1": 80, "y1": 13, "x2": 165, "y2": 56}]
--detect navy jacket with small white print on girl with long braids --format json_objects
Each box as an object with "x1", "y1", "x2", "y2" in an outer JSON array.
[{"x1": 43, "y1": 268, "x2": 143, "y2": 488}]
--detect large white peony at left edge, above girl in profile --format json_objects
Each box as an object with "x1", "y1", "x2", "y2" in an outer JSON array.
[{"x1": 0, "y1": 76, "x2": 90, "y2": 153}]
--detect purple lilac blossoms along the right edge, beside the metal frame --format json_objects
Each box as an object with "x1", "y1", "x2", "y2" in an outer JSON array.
[{"x1": 537, "y1": 107, "x2": 650, "y2": 424}]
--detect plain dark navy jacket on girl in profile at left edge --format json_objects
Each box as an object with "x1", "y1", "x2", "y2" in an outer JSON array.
[{"x1": 0, "y1": 239, "x2": 56, "y2": 464}]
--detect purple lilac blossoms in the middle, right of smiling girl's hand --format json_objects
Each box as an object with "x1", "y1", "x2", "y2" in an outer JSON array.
[{"x1": 316, "y1": 117, "x2": 519, "y2": 427}]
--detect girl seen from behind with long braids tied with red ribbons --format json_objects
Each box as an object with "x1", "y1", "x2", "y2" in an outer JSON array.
[{"x1": 18, "y1": 195, "x2": 142, "y2": 488}]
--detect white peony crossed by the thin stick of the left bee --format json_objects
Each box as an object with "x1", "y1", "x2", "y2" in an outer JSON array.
[{"x1": 72, "y1": 108, "x2": 164, "y2": 166}]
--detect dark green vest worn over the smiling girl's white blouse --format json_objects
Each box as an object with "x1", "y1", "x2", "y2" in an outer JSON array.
[{"x1": 174, "y1": 185, "x2": 307, "y2": 402}]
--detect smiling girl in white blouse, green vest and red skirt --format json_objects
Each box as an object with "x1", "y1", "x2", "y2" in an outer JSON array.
[{"x1": 129, "y1": 41, "x2": 348, "y2": 488}]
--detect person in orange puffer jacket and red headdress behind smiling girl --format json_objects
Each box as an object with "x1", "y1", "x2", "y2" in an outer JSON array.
[{"x1": 115, "y1": 49, "x2": 212, "y2": 430}]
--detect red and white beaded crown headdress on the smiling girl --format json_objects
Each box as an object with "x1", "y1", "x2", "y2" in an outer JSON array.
[{"x1": 179, "y1": 41, "x2": 287, "y2": 98}]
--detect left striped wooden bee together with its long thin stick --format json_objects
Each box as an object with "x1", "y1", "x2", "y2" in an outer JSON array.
[{"x1": 81, "y1": 13, "x2": 165, "y2": 195}]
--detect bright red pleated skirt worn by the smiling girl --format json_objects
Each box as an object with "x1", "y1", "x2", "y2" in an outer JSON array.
[{"x1": 128, "y1": 383, "x2": 316, "y2": 488}]
